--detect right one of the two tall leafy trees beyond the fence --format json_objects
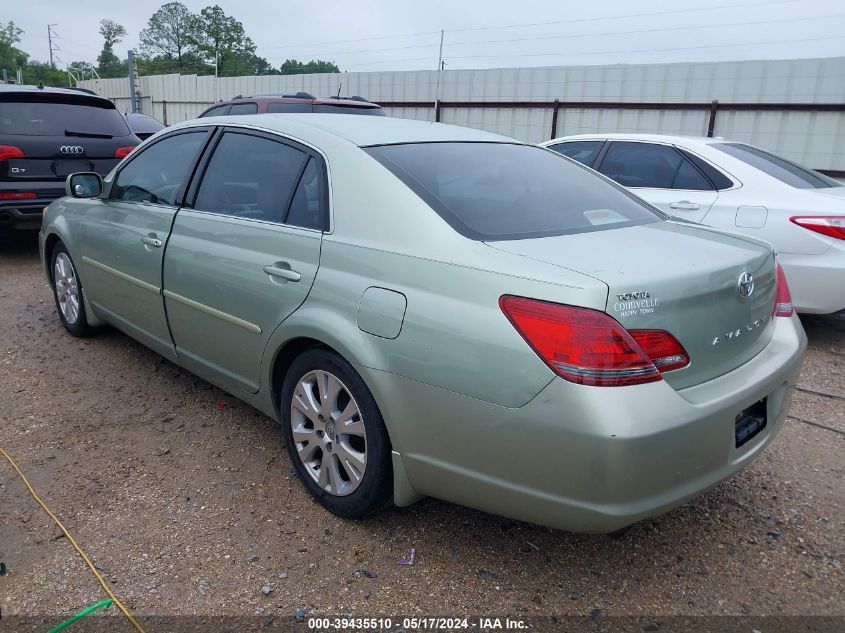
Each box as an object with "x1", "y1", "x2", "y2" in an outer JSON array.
[{"x1": 197, "y1": 5, "x2": 256, "y2": 77}]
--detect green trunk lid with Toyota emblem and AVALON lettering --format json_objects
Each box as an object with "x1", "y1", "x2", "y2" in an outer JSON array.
[{"x1": 487, "y1": 222, "x2": 775, "y2": 389}]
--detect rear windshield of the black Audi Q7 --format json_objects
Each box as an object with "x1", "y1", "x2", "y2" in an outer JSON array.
[{"x1": 0, "y1": 94, "x2": 131, "y2": 138}]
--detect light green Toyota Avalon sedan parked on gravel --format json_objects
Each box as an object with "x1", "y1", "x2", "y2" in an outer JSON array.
[{"x1": 40, "y1": 114, "x2": 806, "y2": 532}]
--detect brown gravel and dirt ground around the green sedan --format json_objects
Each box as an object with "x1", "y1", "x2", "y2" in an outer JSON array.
[{"x1": 0, "y1": 232, "x2": 845, "y2": 631}]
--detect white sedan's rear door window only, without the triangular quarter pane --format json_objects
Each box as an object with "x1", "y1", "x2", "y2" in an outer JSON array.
[{"x1": 598, "y1": 142, "x2": 682, "y2": 189}]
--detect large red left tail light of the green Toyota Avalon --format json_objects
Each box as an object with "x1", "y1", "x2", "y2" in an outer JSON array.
[{"x1": 499, "y1": 295, "x2": 689, "y2": 387}]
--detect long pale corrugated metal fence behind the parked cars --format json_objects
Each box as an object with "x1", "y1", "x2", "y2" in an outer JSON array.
[{"x1": 79, "y1": 57, "x2": 845, "y2": 170}]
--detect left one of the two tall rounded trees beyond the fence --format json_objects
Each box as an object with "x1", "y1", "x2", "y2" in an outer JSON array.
[{"x1": 140, "y1": 2, "x2": 203, "y2": 73}]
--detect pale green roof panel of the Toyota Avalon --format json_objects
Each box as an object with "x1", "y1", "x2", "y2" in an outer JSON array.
[{"x1": 185, "y1": 113, "x2": 523, "y2": 147}]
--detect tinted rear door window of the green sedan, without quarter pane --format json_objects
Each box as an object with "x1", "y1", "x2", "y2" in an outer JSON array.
[{"x1": 194, "y1": 132, "x2": 308, "y2": 222}]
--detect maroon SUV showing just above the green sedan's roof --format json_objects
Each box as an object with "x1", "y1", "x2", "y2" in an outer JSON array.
[{"x1": 200, "y1": 92, "x2": 384, "y2": 117}]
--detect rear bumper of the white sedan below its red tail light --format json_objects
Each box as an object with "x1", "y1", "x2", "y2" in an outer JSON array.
[{"x1": 778, "y1": 243, "x2": 845, "y2": 314}]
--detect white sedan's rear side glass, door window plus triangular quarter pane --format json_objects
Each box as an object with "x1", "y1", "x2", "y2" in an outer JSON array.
[{"x1": 598, "y1": 141, "x2": 713, "y2": 191}]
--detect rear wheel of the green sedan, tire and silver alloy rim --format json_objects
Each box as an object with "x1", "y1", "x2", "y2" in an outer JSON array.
[{"x1": 280, "y1": 348, "x2": 393, "y2": 518}]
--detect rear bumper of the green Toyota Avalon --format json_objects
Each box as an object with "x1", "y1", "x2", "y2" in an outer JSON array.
[{"x1": 359, "y1": 317, "x2": 806, "y2": 532}]
